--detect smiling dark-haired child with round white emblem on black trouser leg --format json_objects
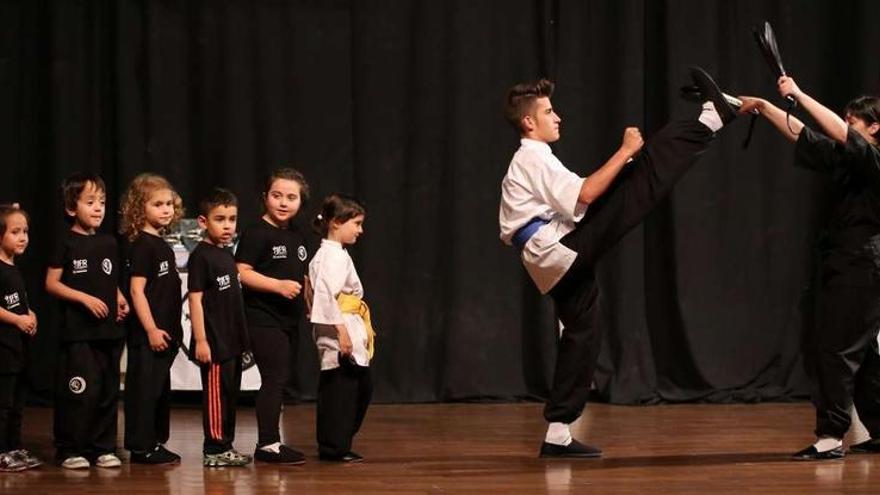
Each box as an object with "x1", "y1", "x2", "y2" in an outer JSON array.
[{"x1": 46, "y1": 173, "x2": 128, "y2": 469}]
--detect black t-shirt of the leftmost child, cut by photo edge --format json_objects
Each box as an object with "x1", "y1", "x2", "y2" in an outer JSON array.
[{"x1": 0, "y1": 261, "x2": 30, "y2": 373}]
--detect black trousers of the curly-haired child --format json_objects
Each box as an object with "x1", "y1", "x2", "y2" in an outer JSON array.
[{"x1": 125, "y1": 345, "x2": 178, "y2": 452}]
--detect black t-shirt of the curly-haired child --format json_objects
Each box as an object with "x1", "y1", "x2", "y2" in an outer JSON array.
[{"x1": 128, "y1": 232, "x2": 183, "y2": 346}]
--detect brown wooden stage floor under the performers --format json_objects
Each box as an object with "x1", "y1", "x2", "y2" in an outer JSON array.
[{"x1": 0, "y1": 403, "x2": 880, "y2": 495}]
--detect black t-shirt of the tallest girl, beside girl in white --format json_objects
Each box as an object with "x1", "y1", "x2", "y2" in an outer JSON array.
[{"x1": 235, "y1": 219, "x2": 309, "y2": 330}]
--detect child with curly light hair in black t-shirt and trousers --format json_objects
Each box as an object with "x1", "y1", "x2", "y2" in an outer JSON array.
[{"x1": 121, "y1": 174, "x2": 183, "y2": 464}]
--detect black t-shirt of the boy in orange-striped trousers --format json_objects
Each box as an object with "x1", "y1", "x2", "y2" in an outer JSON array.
[{"x1": 187, "y1": 242, "x2": 248, "y2": 362}]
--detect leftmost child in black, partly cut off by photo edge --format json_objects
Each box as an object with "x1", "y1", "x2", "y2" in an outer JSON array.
[{"x1": 0, "y1": 205, "x2": 43, "y2": 472}]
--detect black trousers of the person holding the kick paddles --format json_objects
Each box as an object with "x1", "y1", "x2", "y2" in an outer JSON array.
[{"x1": 804, "y1": 286, "x2": 880, "y2": 438}]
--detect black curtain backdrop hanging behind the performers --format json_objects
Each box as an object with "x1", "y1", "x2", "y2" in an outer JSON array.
[{"x1": 0, "y1": 0, "x2": 880, "y2": 403}]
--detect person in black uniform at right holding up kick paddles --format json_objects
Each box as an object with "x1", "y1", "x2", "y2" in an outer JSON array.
[{"x1": 742, "y1": 76, "x2": 880, "y2": 460}]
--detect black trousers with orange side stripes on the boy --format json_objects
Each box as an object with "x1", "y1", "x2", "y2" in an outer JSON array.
[{"x1": 200, "y1": 357, "x2": 241, "y2": 454}]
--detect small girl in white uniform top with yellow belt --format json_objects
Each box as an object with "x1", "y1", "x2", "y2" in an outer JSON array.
[{"x1": 309, "y1": 194, "x2": 373, "y2": 462}]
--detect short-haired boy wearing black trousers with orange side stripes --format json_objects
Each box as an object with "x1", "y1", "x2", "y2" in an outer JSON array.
[{"x1": 187, "y1": 189, "x2": 251, "y2": 467}]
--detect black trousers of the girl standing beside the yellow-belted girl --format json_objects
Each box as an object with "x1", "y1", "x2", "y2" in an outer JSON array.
[{"x1": 249, "y1": 326, "x2": 296, "y2": 447}]
